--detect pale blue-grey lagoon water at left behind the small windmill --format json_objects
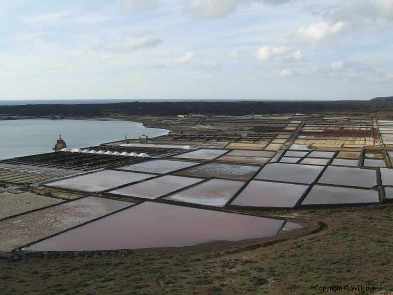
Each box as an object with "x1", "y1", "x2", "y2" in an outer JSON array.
[{"x1": 0, "y1": 119, "x2": 168, "y2": 159}]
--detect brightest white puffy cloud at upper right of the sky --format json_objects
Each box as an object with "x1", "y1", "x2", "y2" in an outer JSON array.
[{"x1": 297, "y1": 21, "x2": 346, "y2": 42}]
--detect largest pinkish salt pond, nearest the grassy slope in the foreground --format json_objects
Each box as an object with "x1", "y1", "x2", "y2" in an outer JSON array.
[{"x1": 24, "y1": 202, "x2": 284, "y2": 251}]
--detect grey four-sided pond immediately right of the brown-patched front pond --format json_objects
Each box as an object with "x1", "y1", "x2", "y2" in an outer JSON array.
[{"x1": 231, "y1": 180, "x2": 308, "y2": 208}]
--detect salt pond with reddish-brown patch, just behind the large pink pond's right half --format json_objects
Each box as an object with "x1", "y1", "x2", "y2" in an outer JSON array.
[{"x1": 165, "y1": 179, "x2": 244, "y2": 207}]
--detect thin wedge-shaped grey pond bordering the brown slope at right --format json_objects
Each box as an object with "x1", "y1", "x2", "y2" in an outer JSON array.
[{"x1": 302, "y1": 185, "x2": 379, "y2": 205}]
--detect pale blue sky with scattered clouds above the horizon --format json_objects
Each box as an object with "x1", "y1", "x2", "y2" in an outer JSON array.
[{"x1": 0, "y1": 0, "x2": 393, "y2": 100}]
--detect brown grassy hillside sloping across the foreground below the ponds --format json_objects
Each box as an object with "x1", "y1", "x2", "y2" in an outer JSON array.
[{"x1": 0, "y1": 205, "x2": 393, "y2": 295}]
